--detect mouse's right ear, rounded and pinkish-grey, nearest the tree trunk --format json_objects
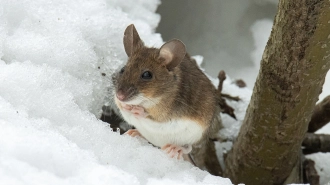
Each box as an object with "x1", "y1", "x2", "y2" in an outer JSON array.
[{"x1": 159, "y1": 39, "x2": 186, "y2": 71}]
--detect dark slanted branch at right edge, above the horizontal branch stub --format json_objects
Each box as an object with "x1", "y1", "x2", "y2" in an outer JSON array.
[{"x1": 308, "y1": 96, "x2": 330, "y2": 132}]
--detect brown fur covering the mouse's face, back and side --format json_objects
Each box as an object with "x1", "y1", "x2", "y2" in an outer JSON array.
[{"x1": 114, "y1": 24, "x2": 220, "y2": 137}]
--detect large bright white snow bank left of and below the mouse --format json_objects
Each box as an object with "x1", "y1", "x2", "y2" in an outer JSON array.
[{"x1": 0, "y1": 0, "x2": 231, "y2": 185}]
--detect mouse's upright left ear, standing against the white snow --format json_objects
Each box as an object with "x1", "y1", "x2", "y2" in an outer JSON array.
[{"x1": 123, "y1": 24, "x2": 144, "y2": 57}]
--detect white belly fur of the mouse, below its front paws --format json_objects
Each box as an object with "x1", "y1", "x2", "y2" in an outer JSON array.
[{"x1": 120, "y1": 110, "x2": 204, "y2": 147}]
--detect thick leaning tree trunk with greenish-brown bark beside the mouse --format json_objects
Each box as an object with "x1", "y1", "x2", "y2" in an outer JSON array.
[{"x1": 224, "y1": 0, "x2": 330, "y2": 185}]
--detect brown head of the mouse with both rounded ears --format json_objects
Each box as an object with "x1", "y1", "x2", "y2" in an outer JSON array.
[{"x1": 113, "y1": 24, "x2": 186, "y2": 105}]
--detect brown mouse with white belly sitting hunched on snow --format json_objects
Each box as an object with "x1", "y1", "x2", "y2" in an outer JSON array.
[{"x1": 112, "y1": 24, "x2": 221, "y2": 159}]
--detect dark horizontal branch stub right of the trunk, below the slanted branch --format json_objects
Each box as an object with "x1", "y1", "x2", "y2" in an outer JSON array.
[{"x1": 302, "y1": 133, "x2": 330, "y2": 155}]
